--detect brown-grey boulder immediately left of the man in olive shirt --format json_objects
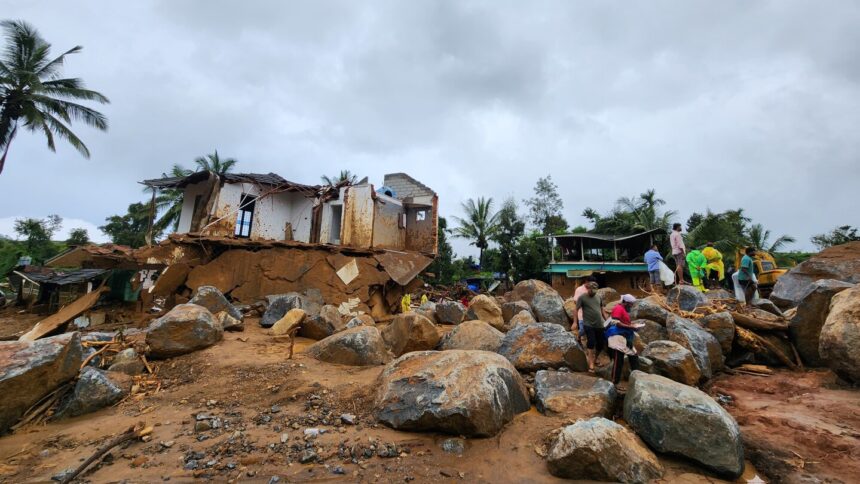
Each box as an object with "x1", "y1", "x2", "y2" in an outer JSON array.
[{"x1": 499, "y1": 323, "x2": 588, "y2": 371}]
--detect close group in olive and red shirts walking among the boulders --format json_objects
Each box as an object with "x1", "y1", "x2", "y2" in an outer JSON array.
[{"x1": 573, "y1": 276, "x2": 639, "y2": 384}]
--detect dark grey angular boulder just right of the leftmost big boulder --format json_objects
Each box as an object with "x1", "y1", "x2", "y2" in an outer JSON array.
[{"x1": 57, "y1": 366, "x2": 133, "y2": 418}]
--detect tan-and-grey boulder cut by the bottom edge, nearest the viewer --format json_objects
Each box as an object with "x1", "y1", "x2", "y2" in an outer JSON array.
[{"x1": 547, "y1": 417, "x2": 663, "y2": 483}]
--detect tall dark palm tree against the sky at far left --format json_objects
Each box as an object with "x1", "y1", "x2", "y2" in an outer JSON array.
[{"x1": 0, "y1": 20, "x2": 109, "y2": 173}]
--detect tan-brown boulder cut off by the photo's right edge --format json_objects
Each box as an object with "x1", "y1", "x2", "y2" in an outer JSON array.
[{"x1": 819, "y1": 286, "x2": 860, "y2": 383}]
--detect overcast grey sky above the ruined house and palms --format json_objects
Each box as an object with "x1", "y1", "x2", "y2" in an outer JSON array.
[{"x1": 0, "y1": 0, "x2": 860, "y2": 254}]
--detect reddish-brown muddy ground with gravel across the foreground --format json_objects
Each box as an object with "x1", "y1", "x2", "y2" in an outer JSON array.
[{"x1": 0, "y1": 319, "x2": 860, "y2": 483}]
